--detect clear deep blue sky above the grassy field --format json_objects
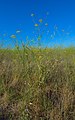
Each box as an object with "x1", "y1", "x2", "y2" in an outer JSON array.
[{"x1": 0, "y1": 0, "x2": 75, "y2": 46}]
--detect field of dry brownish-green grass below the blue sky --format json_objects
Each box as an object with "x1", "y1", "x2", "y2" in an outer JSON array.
[{"x1": 0, "y1": 46, "x2": 75, "y2": 120}]
